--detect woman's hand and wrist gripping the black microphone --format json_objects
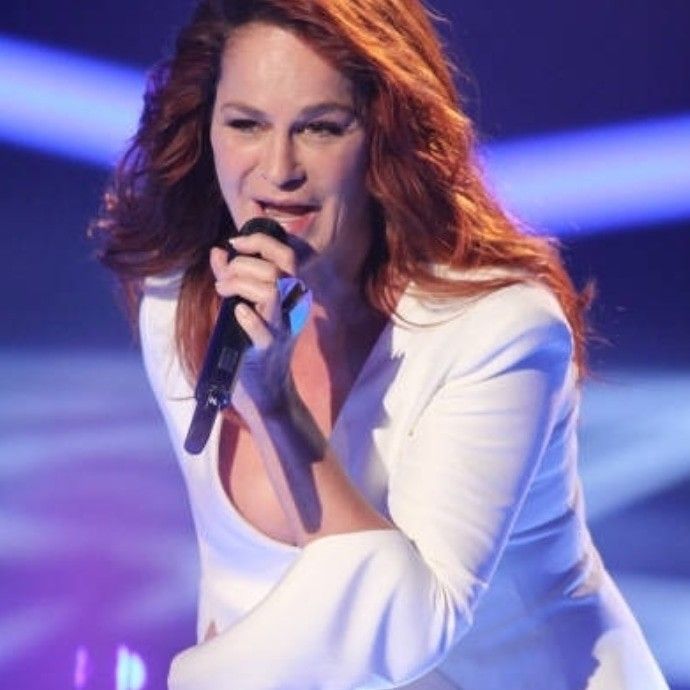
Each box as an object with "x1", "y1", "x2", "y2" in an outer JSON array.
[{"x1": 210, "y1": 233, "x2": 304, "y2": 426}]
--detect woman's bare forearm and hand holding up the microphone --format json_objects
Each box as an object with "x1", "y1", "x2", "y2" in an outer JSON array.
[{"x1": 211, "y1": 233, "x2": 393, "y2": 546}]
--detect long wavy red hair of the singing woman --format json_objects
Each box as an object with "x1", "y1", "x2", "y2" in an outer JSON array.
[{"x1": 91, "y1": 0, "x2": 589, "y2": 378}]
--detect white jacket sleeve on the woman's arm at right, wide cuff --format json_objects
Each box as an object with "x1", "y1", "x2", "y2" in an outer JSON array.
[{"x1": 169, "y1": 288, "x2": 572, "y2": 690}]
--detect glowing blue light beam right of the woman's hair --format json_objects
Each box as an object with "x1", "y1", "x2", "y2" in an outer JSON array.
[{"x1": 485, "y1": 115, "x2": 690, "y2": 235}]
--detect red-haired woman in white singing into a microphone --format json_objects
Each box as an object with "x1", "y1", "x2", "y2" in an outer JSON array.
[{"x1": 91, "y1": 0, "x2": 666, "y2": 690}]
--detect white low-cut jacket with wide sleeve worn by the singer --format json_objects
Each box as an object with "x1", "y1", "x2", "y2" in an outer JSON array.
[{"x1": 140, "y1": 272, "x2": 668, "y2": 690}]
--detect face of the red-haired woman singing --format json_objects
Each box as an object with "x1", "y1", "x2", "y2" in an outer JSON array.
[{"x1": 211, "y1": 23, "x2": 370, "y2": 277}]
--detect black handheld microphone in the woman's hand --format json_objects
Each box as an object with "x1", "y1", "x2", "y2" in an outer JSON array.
[{"x1": 184, "y1": 217, "x2": 287, "y2": 455}]
